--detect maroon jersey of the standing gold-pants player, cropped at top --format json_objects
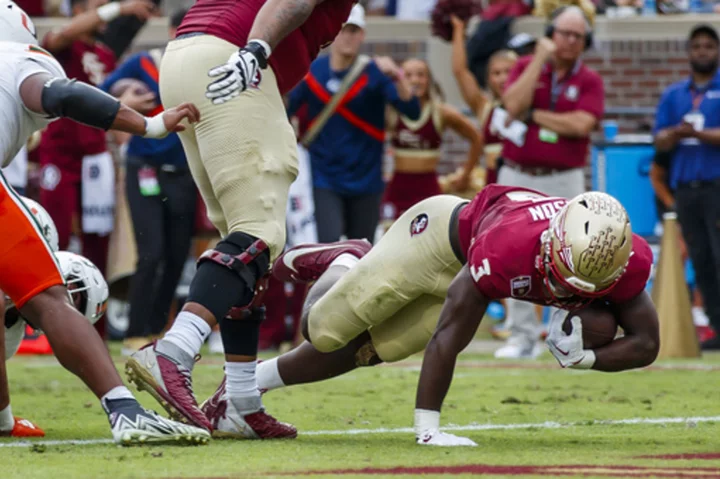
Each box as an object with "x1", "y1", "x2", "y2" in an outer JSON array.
[{"x1": 177, "y1": 0, "x2": 356, "y2": 94}]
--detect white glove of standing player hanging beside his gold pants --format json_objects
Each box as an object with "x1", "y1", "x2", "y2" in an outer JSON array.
[{"x1": 205, "y1": 41, "x2": 269, "y2": 105}]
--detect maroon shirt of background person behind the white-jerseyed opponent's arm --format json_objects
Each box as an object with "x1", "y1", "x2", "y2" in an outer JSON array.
[{"x1": 39, "y1": 41, "x2": 115, "y2": 172}]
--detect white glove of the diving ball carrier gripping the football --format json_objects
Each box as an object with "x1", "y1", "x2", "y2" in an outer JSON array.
[{"x1": 545, "y1": 310, "x2": 595, "y2": 369}]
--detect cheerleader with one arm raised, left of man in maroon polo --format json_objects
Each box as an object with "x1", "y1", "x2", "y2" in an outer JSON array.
[{"x1": 452, "y1": 16, "x2": 516, "y2": 184}]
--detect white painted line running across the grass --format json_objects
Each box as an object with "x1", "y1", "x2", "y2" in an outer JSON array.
[{"x1": 0, "y1": 416, "x2": 720, "y2": 449}]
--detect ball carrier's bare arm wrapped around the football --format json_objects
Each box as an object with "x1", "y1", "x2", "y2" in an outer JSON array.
[{"x1": 592, "y1": 291, "x2": 660, "y2": 372}]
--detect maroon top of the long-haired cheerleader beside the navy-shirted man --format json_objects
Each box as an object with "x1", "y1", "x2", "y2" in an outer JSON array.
[{"x1": 390, "y1": 102, "x2": 443, "y2": 155}]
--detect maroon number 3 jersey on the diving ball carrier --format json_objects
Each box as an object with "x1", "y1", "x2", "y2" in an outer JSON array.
[{"x1": 459, "y1": 185, "x2": 653, "y2": 308}]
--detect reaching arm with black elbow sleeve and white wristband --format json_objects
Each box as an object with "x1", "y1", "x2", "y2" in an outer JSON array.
[{"x1": 20, "y1": 73, "x2": 200, "y2": 138}]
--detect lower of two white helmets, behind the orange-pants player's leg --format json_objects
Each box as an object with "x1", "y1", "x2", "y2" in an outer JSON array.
[{"x1": 55, "y1": 251, "x2": 109, "y2": 324}]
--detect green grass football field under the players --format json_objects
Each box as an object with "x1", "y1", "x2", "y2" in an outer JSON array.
[{"x1": 0, "y1": 344, "x2": 720, "y2": 479}]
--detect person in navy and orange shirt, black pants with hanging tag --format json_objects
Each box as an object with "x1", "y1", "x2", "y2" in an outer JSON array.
[{"x1": 100, "y1": 10, "x2": 196, "y2": 355}]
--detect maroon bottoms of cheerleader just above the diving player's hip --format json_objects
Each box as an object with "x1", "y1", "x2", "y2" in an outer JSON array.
[{"x1": 382, "y1": 172, "x2": 442, "y2": 220}]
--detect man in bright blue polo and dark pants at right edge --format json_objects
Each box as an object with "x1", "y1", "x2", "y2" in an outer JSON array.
[{"x1": 655, "y1": 25, "x2": 720, "y2": 350}]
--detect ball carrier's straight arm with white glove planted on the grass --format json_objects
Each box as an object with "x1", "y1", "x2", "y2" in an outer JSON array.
[{"x1": 415, "y1": 265, "x2": 488, "y2": 445}]
